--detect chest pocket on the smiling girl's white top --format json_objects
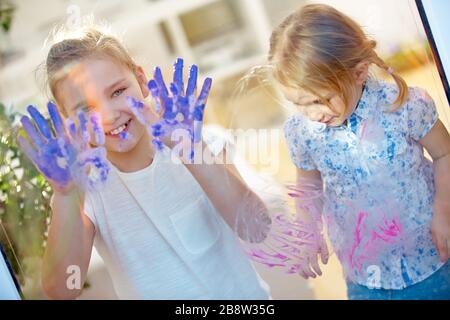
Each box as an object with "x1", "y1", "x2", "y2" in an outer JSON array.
[{"x1": 170, "y1": 196, "x2": 221, "y2": 255}]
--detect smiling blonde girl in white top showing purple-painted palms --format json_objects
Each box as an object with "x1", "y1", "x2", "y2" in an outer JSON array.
[{"x1": 22, "y1": 28, "x2": 270, "y2": 299}]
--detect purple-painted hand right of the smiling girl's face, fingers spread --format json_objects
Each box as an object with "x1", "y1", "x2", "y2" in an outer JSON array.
[{"x1": 125, "y1": 58, "x2": 212, "y2": 160}]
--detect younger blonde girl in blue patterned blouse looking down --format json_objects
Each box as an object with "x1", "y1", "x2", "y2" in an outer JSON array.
[{"x1": 269, "y1": 4, "x2": 450, "y2": 299}]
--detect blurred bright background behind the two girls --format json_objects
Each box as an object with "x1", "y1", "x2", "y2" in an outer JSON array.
[{"x1": 0, "y1": 0, "x2": 450, "y2": 299}]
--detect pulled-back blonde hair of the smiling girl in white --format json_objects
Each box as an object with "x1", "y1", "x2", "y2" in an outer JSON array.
[{"x1": 44, "y1": 23, "x2": 137, "y2": 116}]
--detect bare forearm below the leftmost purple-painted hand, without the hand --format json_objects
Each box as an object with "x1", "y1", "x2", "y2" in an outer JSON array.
[{"x1": 42, "y1": 188, "x2": 95, "y2": 300}]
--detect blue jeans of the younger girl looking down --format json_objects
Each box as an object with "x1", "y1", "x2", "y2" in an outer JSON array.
[{"x1": 347, "y1": 262, "x2": 450, "y2": 300}]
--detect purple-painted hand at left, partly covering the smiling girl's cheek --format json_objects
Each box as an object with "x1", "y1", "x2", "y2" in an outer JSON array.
[{"x1": 18, "y1": 102, "x2": 110, "y2": 190}]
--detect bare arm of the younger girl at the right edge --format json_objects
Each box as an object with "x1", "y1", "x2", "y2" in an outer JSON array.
[{"x1": 419, "y1": 120, "x2": 450, "y2": 261}]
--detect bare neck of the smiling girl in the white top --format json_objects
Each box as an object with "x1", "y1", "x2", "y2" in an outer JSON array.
[{"x1": 107, "y1": 134, "x2": 154, "y2": 172}]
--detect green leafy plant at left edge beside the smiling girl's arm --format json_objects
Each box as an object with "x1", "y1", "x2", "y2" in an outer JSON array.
[{"x1": 0, "y1": 104, "x2": 52, "y2": 297}]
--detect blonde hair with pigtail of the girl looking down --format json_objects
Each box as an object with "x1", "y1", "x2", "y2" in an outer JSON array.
[{"x1": 269, "y1": 4, "x2": 408, "y2": 109}]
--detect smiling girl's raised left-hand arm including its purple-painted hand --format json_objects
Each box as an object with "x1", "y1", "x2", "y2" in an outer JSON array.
[{"x1": 18, "y1": 103, "x2": 109, "y2": 299}]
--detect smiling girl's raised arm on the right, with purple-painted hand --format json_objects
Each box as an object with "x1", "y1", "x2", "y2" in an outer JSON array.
[{"x1": 128, "y1": 58, "x2": 270, "y2": 242}]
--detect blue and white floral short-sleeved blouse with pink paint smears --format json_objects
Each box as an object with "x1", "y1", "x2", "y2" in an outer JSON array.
[{"x1": 285, "y1": 78, "x2": 443, "y2": 289}]
